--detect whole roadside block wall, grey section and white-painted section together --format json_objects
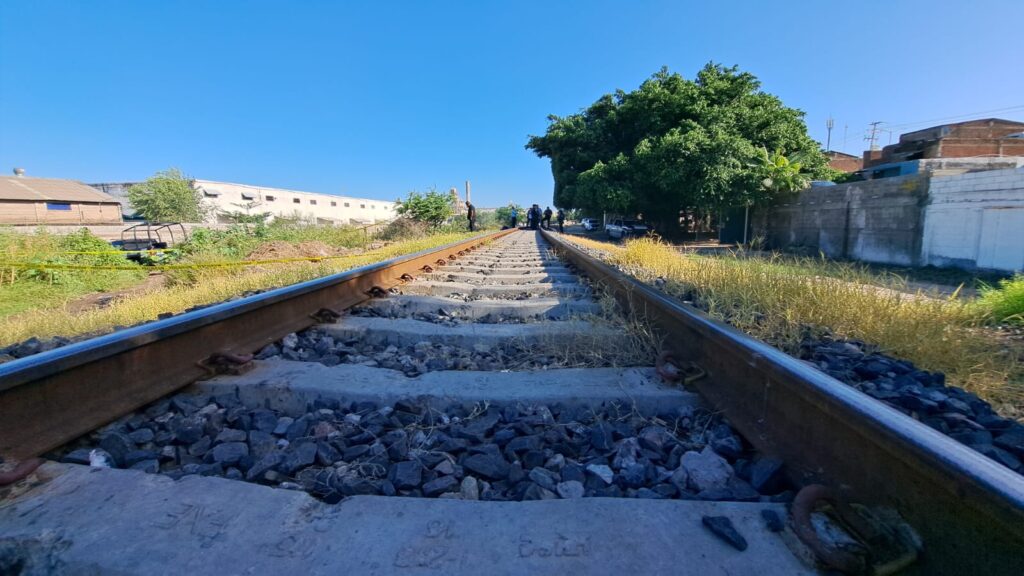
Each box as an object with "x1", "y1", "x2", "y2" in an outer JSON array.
[{"x1": 754, "y1": 167, "x2": 1024, "y2": 272}]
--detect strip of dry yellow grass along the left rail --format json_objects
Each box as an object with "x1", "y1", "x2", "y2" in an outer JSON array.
[{"x1": 0, "y1": 234, "x2": 472, "y2": 346}]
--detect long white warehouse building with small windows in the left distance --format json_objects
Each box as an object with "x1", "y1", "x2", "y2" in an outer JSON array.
[{"x1": 193, "y1": 180, "x2": 397, "y2": 225}]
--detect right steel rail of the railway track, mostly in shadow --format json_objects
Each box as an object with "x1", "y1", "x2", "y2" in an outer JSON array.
[{"x1": 543, "y1": 232, "x2": 1024, "y2": 575}]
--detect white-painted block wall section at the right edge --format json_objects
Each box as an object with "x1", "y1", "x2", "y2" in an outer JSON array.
[{"x1": 922, "y1": 168, "x2": 1024, "y2": 271}]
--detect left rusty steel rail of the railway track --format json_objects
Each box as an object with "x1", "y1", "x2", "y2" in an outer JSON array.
[{"x1": 0, "y1": 231, "x2": 512, "y2": 459}]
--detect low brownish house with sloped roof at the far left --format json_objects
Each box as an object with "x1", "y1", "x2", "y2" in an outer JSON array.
[{"x1": 0, "y1": 170, "x2": 122, "y2": 224}]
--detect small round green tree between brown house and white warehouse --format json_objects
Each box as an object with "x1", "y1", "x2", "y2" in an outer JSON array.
[{"x1": 128, "y1": 168, "x2": 209, "y2": 222}]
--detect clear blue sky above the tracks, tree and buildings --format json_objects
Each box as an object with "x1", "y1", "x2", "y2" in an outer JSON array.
[{"x1": 0, "y1": 0, "x2": 1024, "y2": 206}]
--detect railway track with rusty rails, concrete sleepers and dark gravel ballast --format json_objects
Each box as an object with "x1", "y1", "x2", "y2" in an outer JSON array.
[{"x1": 0, "y1": 232, "x2": 1024, "y2": 574}]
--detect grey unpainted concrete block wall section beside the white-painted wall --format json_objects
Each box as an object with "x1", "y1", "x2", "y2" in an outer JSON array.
[{"x1": 759, "y1": 174, "x2": 928, "y2": 265}]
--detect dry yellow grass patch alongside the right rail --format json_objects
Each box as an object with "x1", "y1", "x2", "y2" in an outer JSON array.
[{"x1": 571, "y1": 231, "x2": 1024, "y2": 405}]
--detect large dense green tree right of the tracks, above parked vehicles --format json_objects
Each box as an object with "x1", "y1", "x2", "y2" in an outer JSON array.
[{"x1": 526, "y1": 64, "x2": 827, "y2": 235}]
